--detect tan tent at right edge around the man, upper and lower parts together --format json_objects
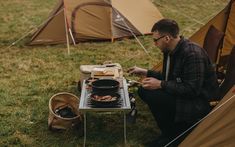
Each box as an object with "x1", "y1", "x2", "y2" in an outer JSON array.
[{"x1": 179, "y1": 3, "x2": 235, "y2": 144}]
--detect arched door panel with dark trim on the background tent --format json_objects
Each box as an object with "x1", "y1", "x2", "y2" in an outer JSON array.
[{"x1": 71, "y1": 3, "x2": 112, "y2": 39}]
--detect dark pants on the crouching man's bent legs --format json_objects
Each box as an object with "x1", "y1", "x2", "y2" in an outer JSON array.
[{"x1": 138, "y1": 87, "x2": 191, "y2": 141}]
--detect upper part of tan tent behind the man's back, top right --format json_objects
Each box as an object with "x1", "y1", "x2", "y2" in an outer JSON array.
[{"x1": 190, "y1": 0, "x2": 235, "y2": 56}]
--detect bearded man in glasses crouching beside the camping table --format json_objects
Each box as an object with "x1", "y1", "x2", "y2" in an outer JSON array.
[{"x1": 129, "y1": 19, "x2": 218, "y2": 146}]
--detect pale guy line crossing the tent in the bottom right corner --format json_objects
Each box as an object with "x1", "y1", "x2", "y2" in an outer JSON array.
[{"x1": 164, "y1": 94, "x2": 235, "y2": 147}]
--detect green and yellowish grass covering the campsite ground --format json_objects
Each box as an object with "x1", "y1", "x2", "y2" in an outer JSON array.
[{"x1": 0, "y1": 0, "x2": 227, "y2": 147}]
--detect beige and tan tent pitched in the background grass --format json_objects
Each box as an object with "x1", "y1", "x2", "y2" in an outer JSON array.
[{"x1": 30, "y1": 0, "x2": 162, "y2": 45}]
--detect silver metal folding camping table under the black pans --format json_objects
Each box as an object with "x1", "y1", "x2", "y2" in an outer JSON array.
[{"x1": 79, "y1": 78, "x2": 131, "y2": 146}]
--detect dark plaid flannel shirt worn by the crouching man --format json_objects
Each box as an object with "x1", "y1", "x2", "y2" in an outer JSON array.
[{"x1": 147, "y1": 37, "x2": 218, "y2": 122}]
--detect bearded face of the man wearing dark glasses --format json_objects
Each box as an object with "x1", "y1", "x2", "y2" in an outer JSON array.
[{"x1": 153, "y1": 32, "x2": 168, "y2": 52}]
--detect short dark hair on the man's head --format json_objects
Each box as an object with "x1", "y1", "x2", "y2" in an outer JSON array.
[{"x1": 151, "y1": 19, "x2": 179, "y2": 38}]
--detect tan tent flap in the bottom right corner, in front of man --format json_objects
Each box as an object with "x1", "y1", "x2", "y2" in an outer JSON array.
[{"x1": 179, "y1": 86, "x2": 235, "y2": 147}]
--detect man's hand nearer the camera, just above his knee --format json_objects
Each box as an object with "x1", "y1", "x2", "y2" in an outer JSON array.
[{"x1": 142, "y1": 77, "x2": 162, "y2": 90}]
